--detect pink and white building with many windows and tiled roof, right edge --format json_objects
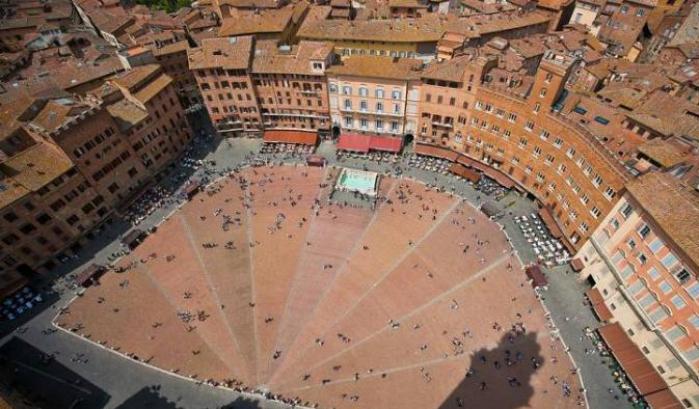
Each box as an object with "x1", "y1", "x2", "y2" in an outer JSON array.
[{"x1": 578, "y1": 172, "x2": 699, "y2": 408}]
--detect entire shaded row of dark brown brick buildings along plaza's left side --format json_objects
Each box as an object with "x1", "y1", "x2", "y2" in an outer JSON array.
[{"x1": 0, "y1": 65, "x2": 191, "y2": 294}]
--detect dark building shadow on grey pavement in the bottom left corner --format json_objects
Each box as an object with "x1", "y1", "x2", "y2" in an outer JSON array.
[{"x1": 0, "y1": 337, "x2": 110, "y2": 409}]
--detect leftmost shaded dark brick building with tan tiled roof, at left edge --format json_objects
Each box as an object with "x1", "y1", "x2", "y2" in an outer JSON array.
[{"x1": 0, "y1": 135, "x2": 108, "y2": 294}]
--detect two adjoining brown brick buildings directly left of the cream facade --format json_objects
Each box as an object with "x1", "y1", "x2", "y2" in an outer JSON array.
[{"x1": 189, "y1": 36, "x2": 333, "y2": 136}]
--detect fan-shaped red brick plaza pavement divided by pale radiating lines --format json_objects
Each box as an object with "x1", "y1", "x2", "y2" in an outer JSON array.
[{"x1": 57, "y1": 166, "x2": 580, "y2": 408}]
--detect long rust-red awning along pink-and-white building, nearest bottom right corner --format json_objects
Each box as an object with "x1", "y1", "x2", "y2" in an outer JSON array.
[{"x1": 598, "y1": 322, "x2": 684, "y2": 409}]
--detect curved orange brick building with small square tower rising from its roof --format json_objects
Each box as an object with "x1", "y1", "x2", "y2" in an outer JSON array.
[{"x1": 417, "y1": 52, "x2": 630, "y2": 250}]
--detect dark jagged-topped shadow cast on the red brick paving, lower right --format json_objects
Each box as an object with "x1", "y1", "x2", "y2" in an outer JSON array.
[{"x1": 440, "y1": 332, "x2": 544, "y2": 409}]
